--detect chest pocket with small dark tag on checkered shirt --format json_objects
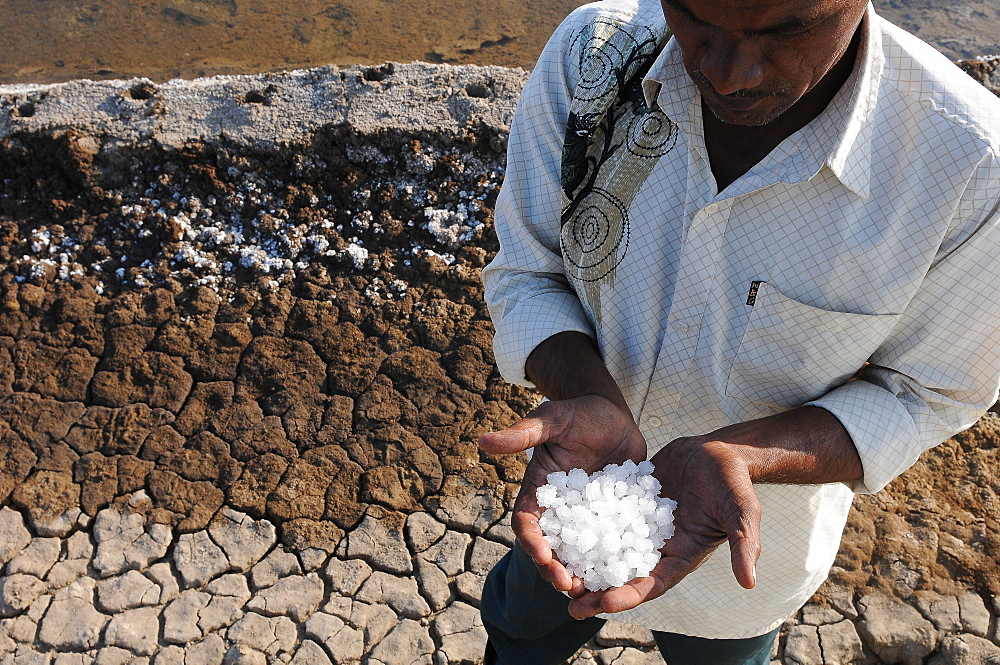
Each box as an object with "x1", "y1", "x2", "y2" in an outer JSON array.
[{"x1": 726, "y1": 282, "x2": 899, "y2": 409}]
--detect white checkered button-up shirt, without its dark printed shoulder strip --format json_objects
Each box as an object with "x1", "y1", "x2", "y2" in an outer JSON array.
[{"x1": 483, "y1": 0, "x2": 1000, "y2": 638}]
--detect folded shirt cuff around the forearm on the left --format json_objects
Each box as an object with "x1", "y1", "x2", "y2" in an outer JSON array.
[{"x1": 493, "y1": 292, "x2": 597, "y2": 388}]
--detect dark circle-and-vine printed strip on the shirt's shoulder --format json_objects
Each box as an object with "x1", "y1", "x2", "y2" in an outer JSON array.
[{"x1": 560, "y1": 18, "x2": 677, "y2": 323}]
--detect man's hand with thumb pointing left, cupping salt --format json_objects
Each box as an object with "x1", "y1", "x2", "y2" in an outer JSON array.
[{"x1": 479, "y1": 395, "x2": 646, "y2": 596}]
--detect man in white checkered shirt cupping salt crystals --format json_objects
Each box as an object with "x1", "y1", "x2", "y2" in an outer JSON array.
[{"x1": 481, "y1": 0, "x2": 1000, "y2": 665}]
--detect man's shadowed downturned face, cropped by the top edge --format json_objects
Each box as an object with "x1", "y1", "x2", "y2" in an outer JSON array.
[{"x1": 660, "y1": 0, "x2": 867, "y2": 126}]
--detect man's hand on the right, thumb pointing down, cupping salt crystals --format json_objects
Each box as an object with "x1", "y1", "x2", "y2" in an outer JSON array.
[{"x1": 569, "y1": 437, "x2": 761, "y2": 619}]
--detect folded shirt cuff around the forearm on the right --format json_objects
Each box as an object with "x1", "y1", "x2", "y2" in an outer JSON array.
[{"x1": 804, "y1": 380, "x2": 921, "y2": 494}]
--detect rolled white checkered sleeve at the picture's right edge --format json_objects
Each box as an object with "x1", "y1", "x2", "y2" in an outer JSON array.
[{"x1": 809, "y1": 153, "x2": 1000, "y2": 493}]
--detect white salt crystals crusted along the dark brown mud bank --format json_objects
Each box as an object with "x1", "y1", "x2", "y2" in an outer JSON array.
[{"x1": 4, "y1": 146, "x2": 503, "y2": 298}]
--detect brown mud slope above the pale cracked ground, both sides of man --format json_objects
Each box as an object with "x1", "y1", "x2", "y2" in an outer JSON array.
[{"x1": 0, "y1": 63, "x2": 1000, "y2": 663}]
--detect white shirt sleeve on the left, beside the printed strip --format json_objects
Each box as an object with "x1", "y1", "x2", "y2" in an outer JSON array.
[{"x1": 483, "y1": 17, "x2": 595, "y2": 386}]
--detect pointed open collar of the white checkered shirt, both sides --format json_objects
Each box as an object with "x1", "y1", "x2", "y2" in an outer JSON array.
[{"x1": 642, "y1": 3, "x2": 884, "y2": 198}]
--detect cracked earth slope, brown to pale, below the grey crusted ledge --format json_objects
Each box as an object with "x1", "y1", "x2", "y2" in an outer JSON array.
[{"x1": 0, "y1": 57, "x2": 1000, "y2": 665}]
